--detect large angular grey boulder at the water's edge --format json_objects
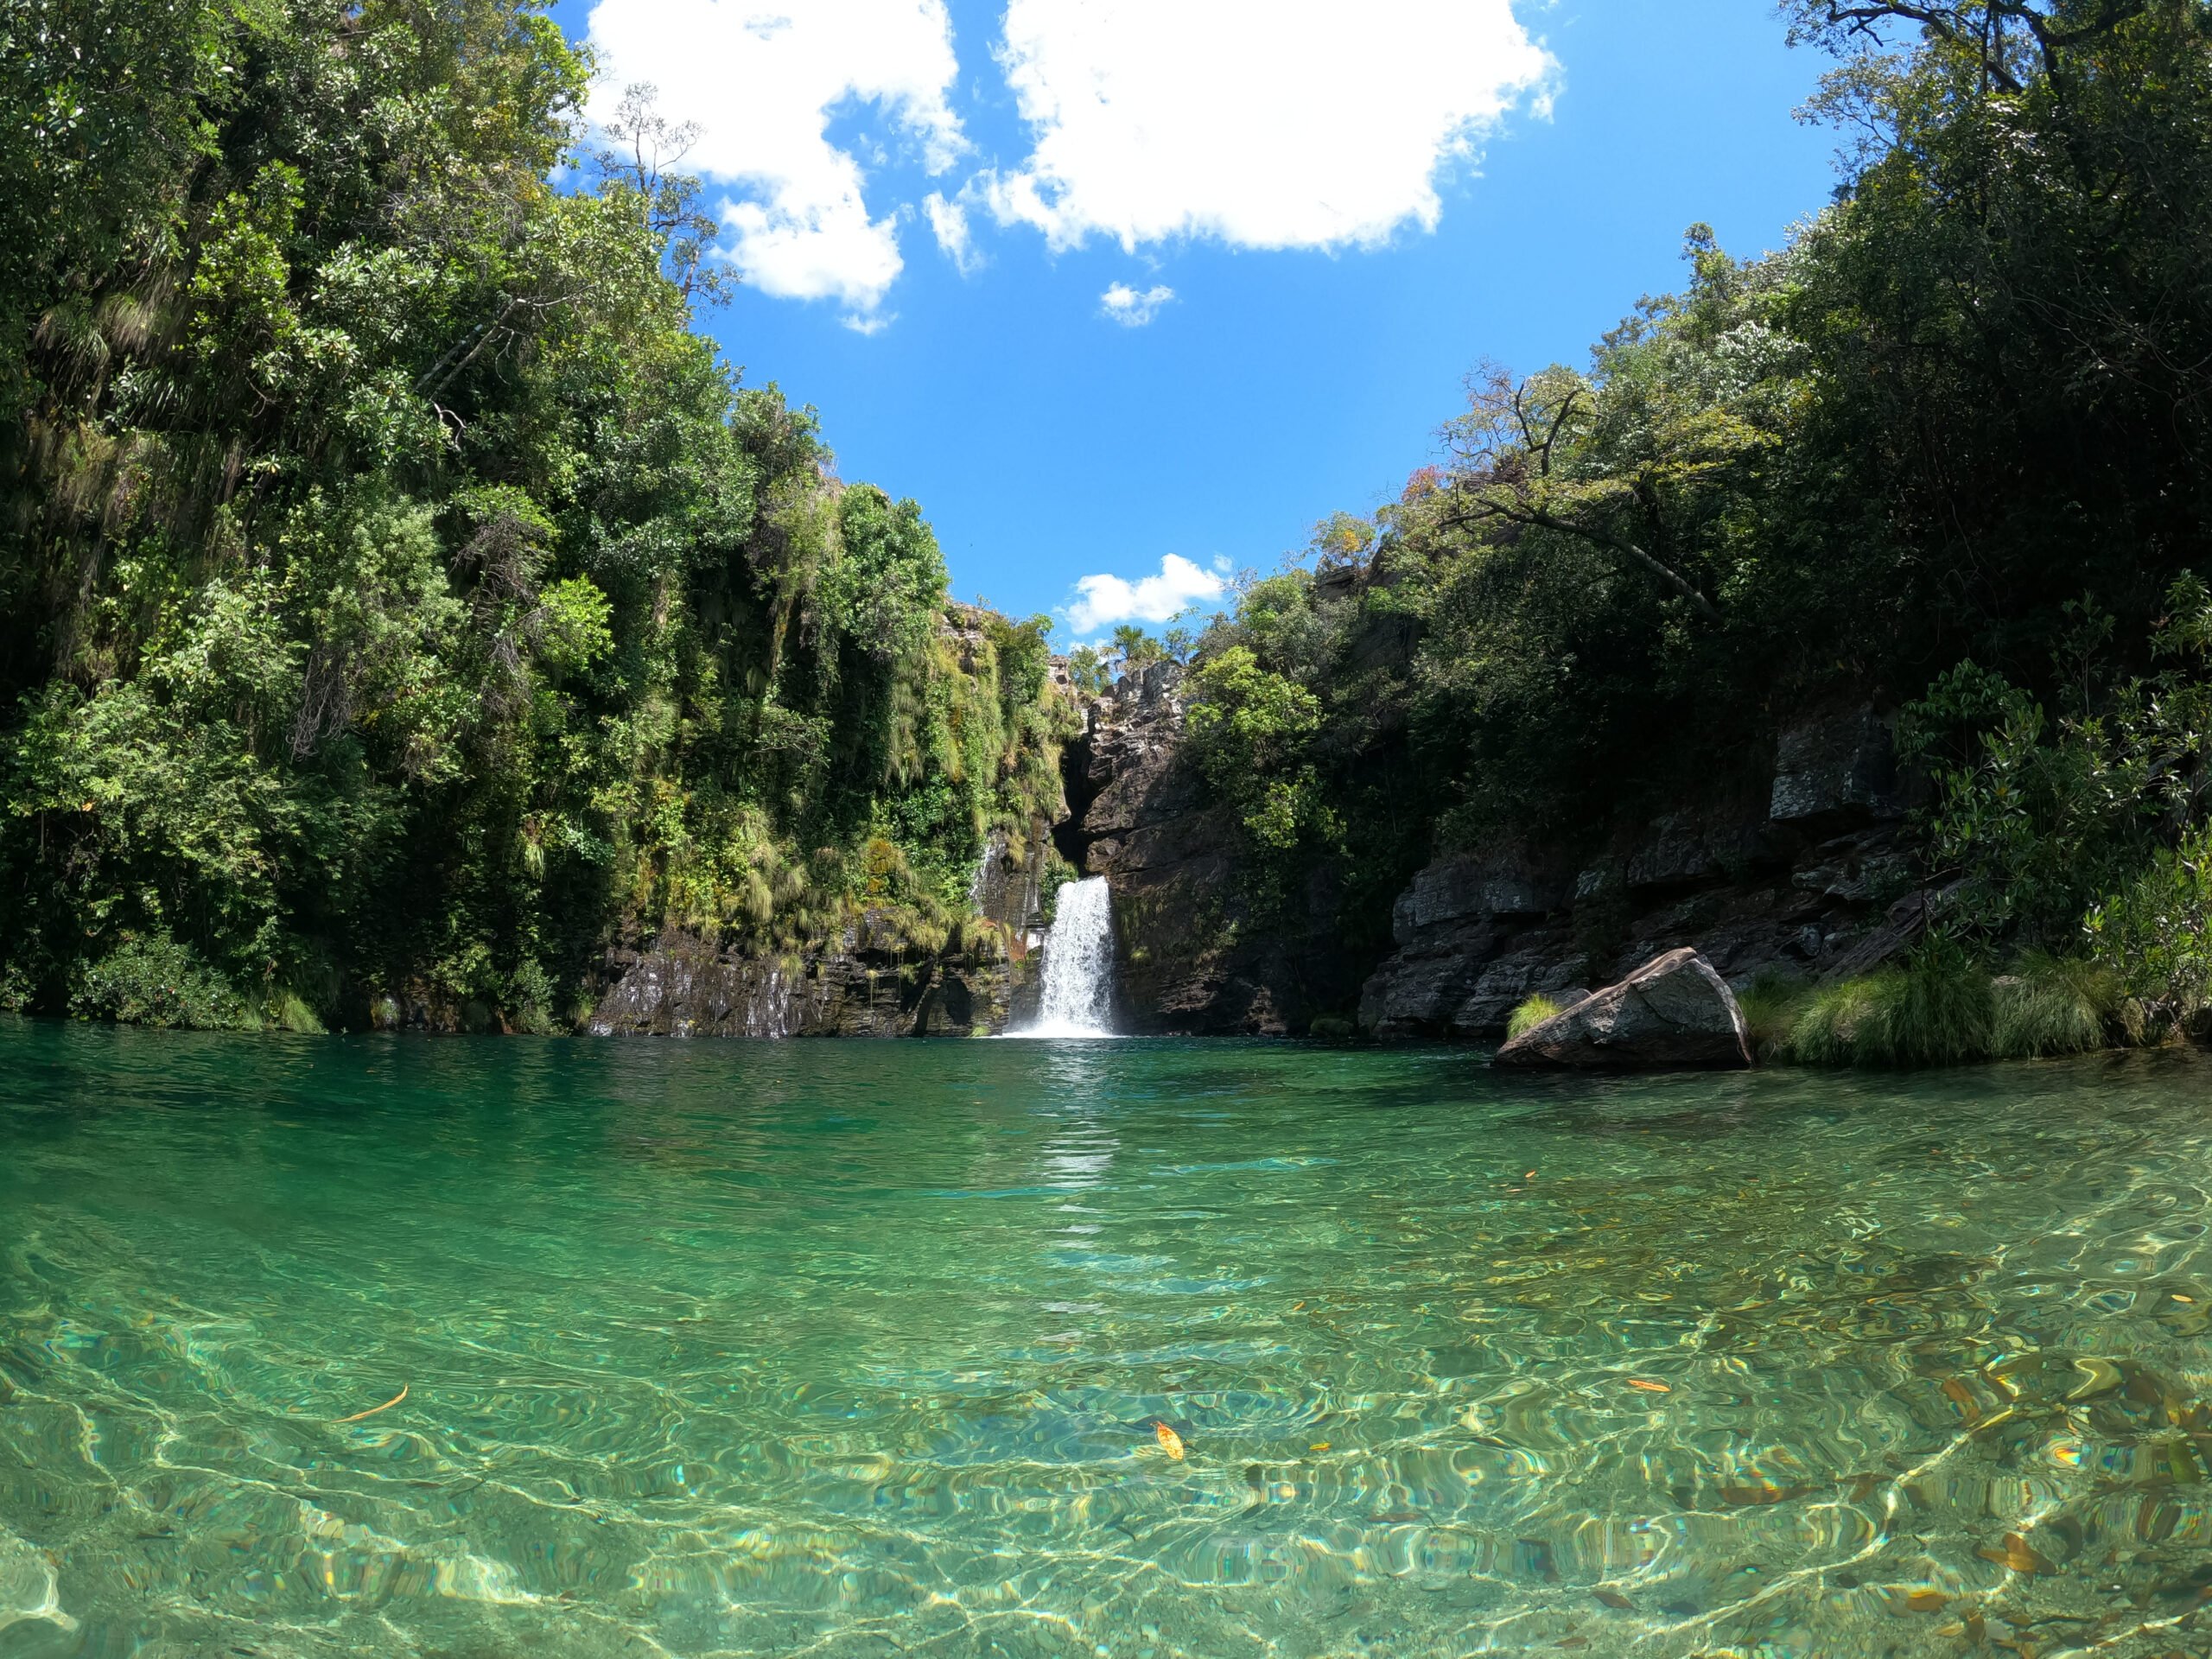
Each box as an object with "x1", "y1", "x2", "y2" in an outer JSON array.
[{"x1": 1497, "y1": 949, "x2": 1752, "y2": 1071}]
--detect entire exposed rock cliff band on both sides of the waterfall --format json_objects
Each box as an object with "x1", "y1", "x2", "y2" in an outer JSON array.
[{"x1": 588, "y1": 664, "x2": 1927, "y2": 1039}]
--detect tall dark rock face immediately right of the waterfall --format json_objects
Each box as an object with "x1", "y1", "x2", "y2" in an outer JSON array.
[{"x1": 1053, "y1": 664, "x2": 1358, "y2": 1035}]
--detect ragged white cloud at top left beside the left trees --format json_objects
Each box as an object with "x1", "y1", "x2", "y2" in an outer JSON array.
[{"x1": 591, "y1": 0, "x2": 967, "y2": 325}]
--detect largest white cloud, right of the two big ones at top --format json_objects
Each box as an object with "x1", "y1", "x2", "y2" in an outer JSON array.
[{"x1": 978, "y1": 0, "x2": 1555, "y2": 250}]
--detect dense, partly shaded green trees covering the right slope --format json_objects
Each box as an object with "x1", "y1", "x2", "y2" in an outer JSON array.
[{"x1": 1197, "y1": 0, "x2": 2212, "y2": 1013}]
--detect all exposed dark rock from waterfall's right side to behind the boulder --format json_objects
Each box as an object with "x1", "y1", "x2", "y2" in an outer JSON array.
[{"x1": 1055, "y1": 664, "x2": 1923, "y2": 1039}]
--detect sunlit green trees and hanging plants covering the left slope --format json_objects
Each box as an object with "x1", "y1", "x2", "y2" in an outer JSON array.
[{"x1": 0, "y1": 0, "x2": 1066, "y2": 1028}]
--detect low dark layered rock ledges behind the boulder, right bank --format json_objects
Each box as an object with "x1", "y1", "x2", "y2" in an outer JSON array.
[{"x1": 1360, "y1": 706, "x2": 1924, "y2": 1039}]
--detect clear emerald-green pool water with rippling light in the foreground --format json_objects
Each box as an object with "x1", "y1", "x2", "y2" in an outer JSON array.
[{"x1": 0, "y1": 1022, "x2": 2212, "y2": 1659}]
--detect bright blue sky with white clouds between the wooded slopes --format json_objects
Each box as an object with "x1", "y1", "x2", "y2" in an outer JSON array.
[{"x1": 556, "y1": 0, "x2": 1834, "y2": 644}]
